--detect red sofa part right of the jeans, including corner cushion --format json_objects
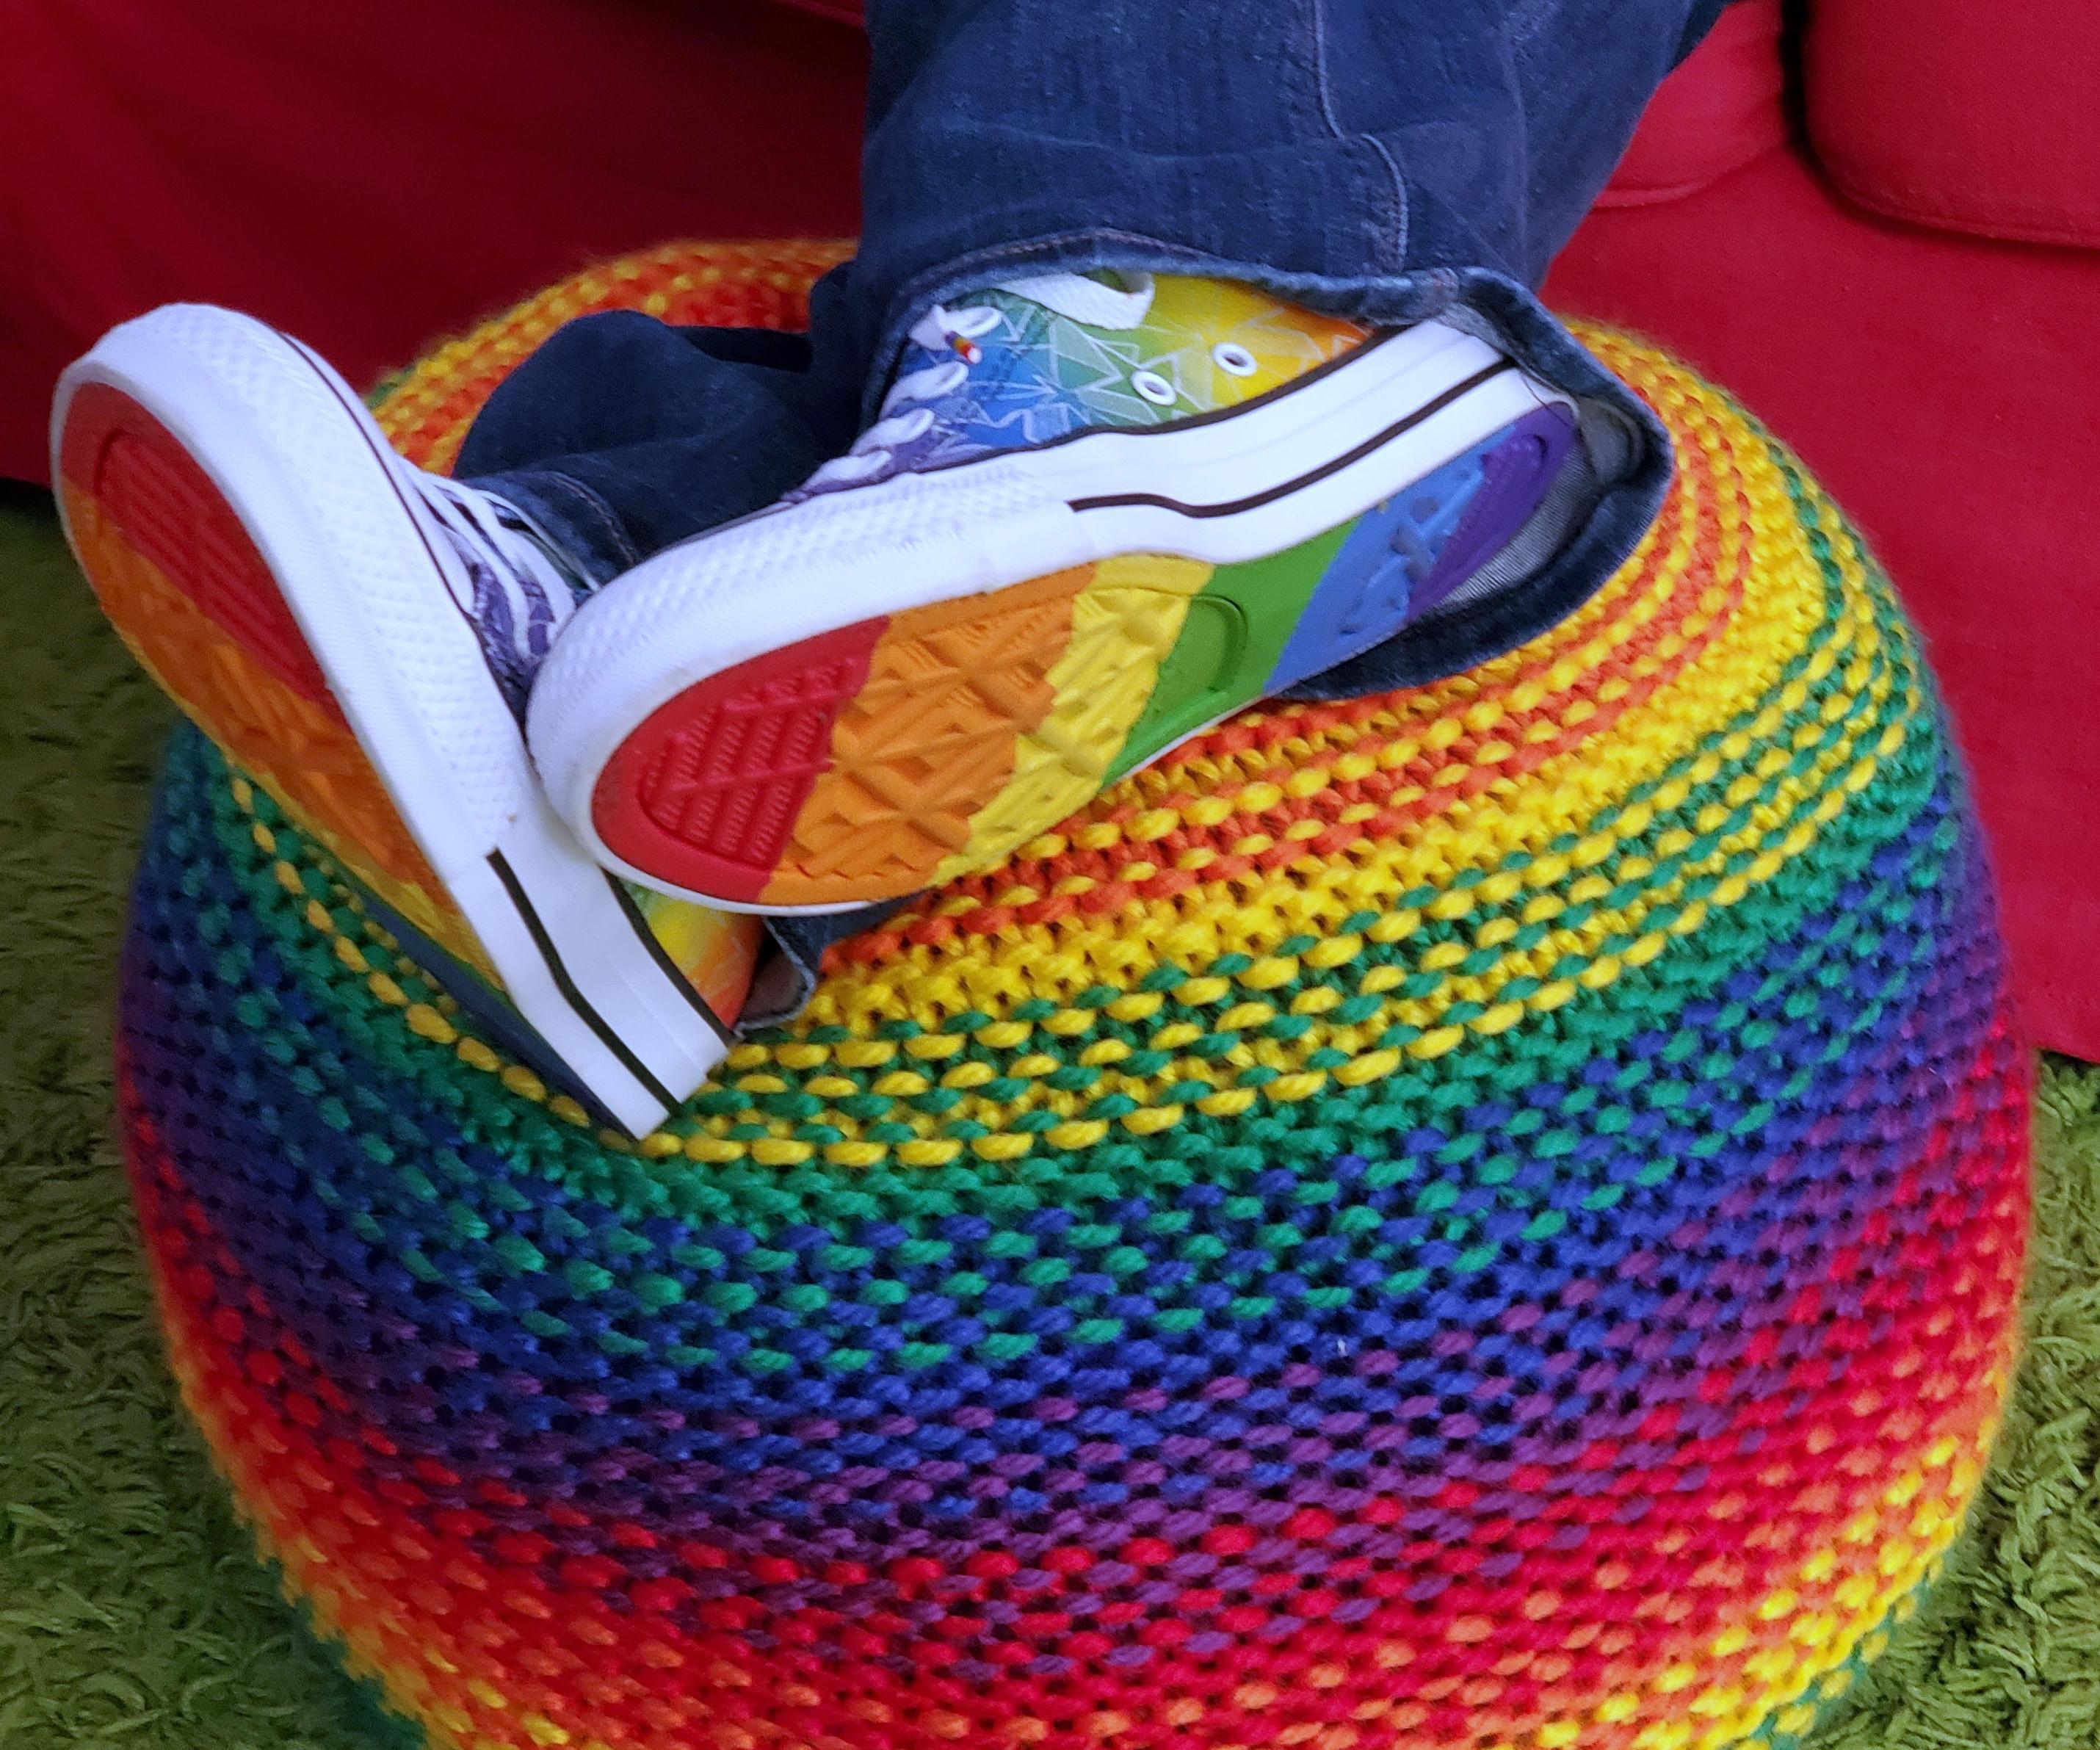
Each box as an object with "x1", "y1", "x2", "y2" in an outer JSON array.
[{"x1": 1546, "y1": 0, "x2": 2100, "y2": 1059}]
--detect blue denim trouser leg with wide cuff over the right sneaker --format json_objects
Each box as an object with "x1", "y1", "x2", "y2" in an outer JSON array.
[{"x1": 838, "y1": 0, "x2": 1726, "y2": 695}]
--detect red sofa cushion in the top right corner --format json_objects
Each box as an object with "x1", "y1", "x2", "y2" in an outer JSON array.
[{"x1": 1804, "y1": 0, "x2": 2100, "y2": 248}]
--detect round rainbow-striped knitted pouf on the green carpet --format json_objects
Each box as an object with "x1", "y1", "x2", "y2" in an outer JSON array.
[{"x1": 120, "y1": 246, "x2": 2027, "y2": 1750}]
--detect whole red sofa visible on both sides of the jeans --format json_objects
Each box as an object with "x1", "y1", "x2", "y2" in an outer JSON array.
[{"x1": 0, "y1": 0, "x2": 2100, "y2": 1057}]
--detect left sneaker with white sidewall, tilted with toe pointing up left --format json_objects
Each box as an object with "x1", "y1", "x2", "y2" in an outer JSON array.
[{"x1": 53, "y1": 305, "x2": 752, "y2": 1132}]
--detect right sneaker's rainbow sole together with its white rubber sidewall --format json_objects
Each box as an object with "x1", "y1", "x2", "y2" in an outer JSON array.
[{"x1": 532, "y1": 324, "x2": 1573, "y2": 912}]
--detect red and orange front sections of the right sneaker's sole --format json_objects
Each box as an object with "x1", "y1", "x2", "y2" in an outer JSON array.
[{"x1": 593, "y1": 567, "x2": 1092, "y2": 905}]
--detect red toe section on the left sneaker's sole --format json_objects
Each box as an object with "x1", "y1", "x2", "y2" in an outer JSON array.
[{"x1": 59, "y1": 383, "x2": 336, "y2": 712}]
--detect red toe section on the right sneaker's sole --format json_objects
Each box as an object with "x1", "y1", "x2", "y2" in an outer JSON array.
[{"x1": 590, "y1": 620, "x2": 888, "y2": 903}]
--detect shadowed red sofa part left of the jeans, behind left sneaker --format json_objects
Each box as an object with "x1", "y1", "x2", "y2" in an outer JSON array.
[{"x1": 0, "y1": 0, "x2": 867, "y2": 479}]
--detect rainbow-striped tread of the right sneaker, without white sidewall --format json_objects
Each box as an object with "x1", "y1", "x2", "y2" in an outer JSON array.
[{"x1": 590, "y1": 408, "x2": 1573, "y2": 910}]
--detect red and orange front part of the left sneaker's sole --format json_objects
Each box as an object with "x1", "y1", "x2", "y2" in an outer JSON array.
[{"x1": 59, "y1": 385, "x2": 460, "y2": 916}]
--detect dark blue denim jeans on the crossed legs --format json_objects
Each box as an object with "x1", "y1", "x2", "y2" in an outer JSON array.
[{"x1": 457, "y1": 0, "x2": 1726, "y2": 1021}]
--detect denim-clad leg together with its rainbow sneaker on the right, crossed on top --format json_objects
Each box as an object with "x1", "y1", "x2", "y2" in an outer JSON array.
[{"x1": 527, "y1": 0, "x2": 1716, "y2": 912}]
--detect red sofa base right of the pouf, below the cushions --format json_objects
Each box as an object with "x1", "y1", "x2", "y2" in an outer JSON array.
[{"x1": 1546, "y1": 30, "x2": 2100, "y2": 1059}]
